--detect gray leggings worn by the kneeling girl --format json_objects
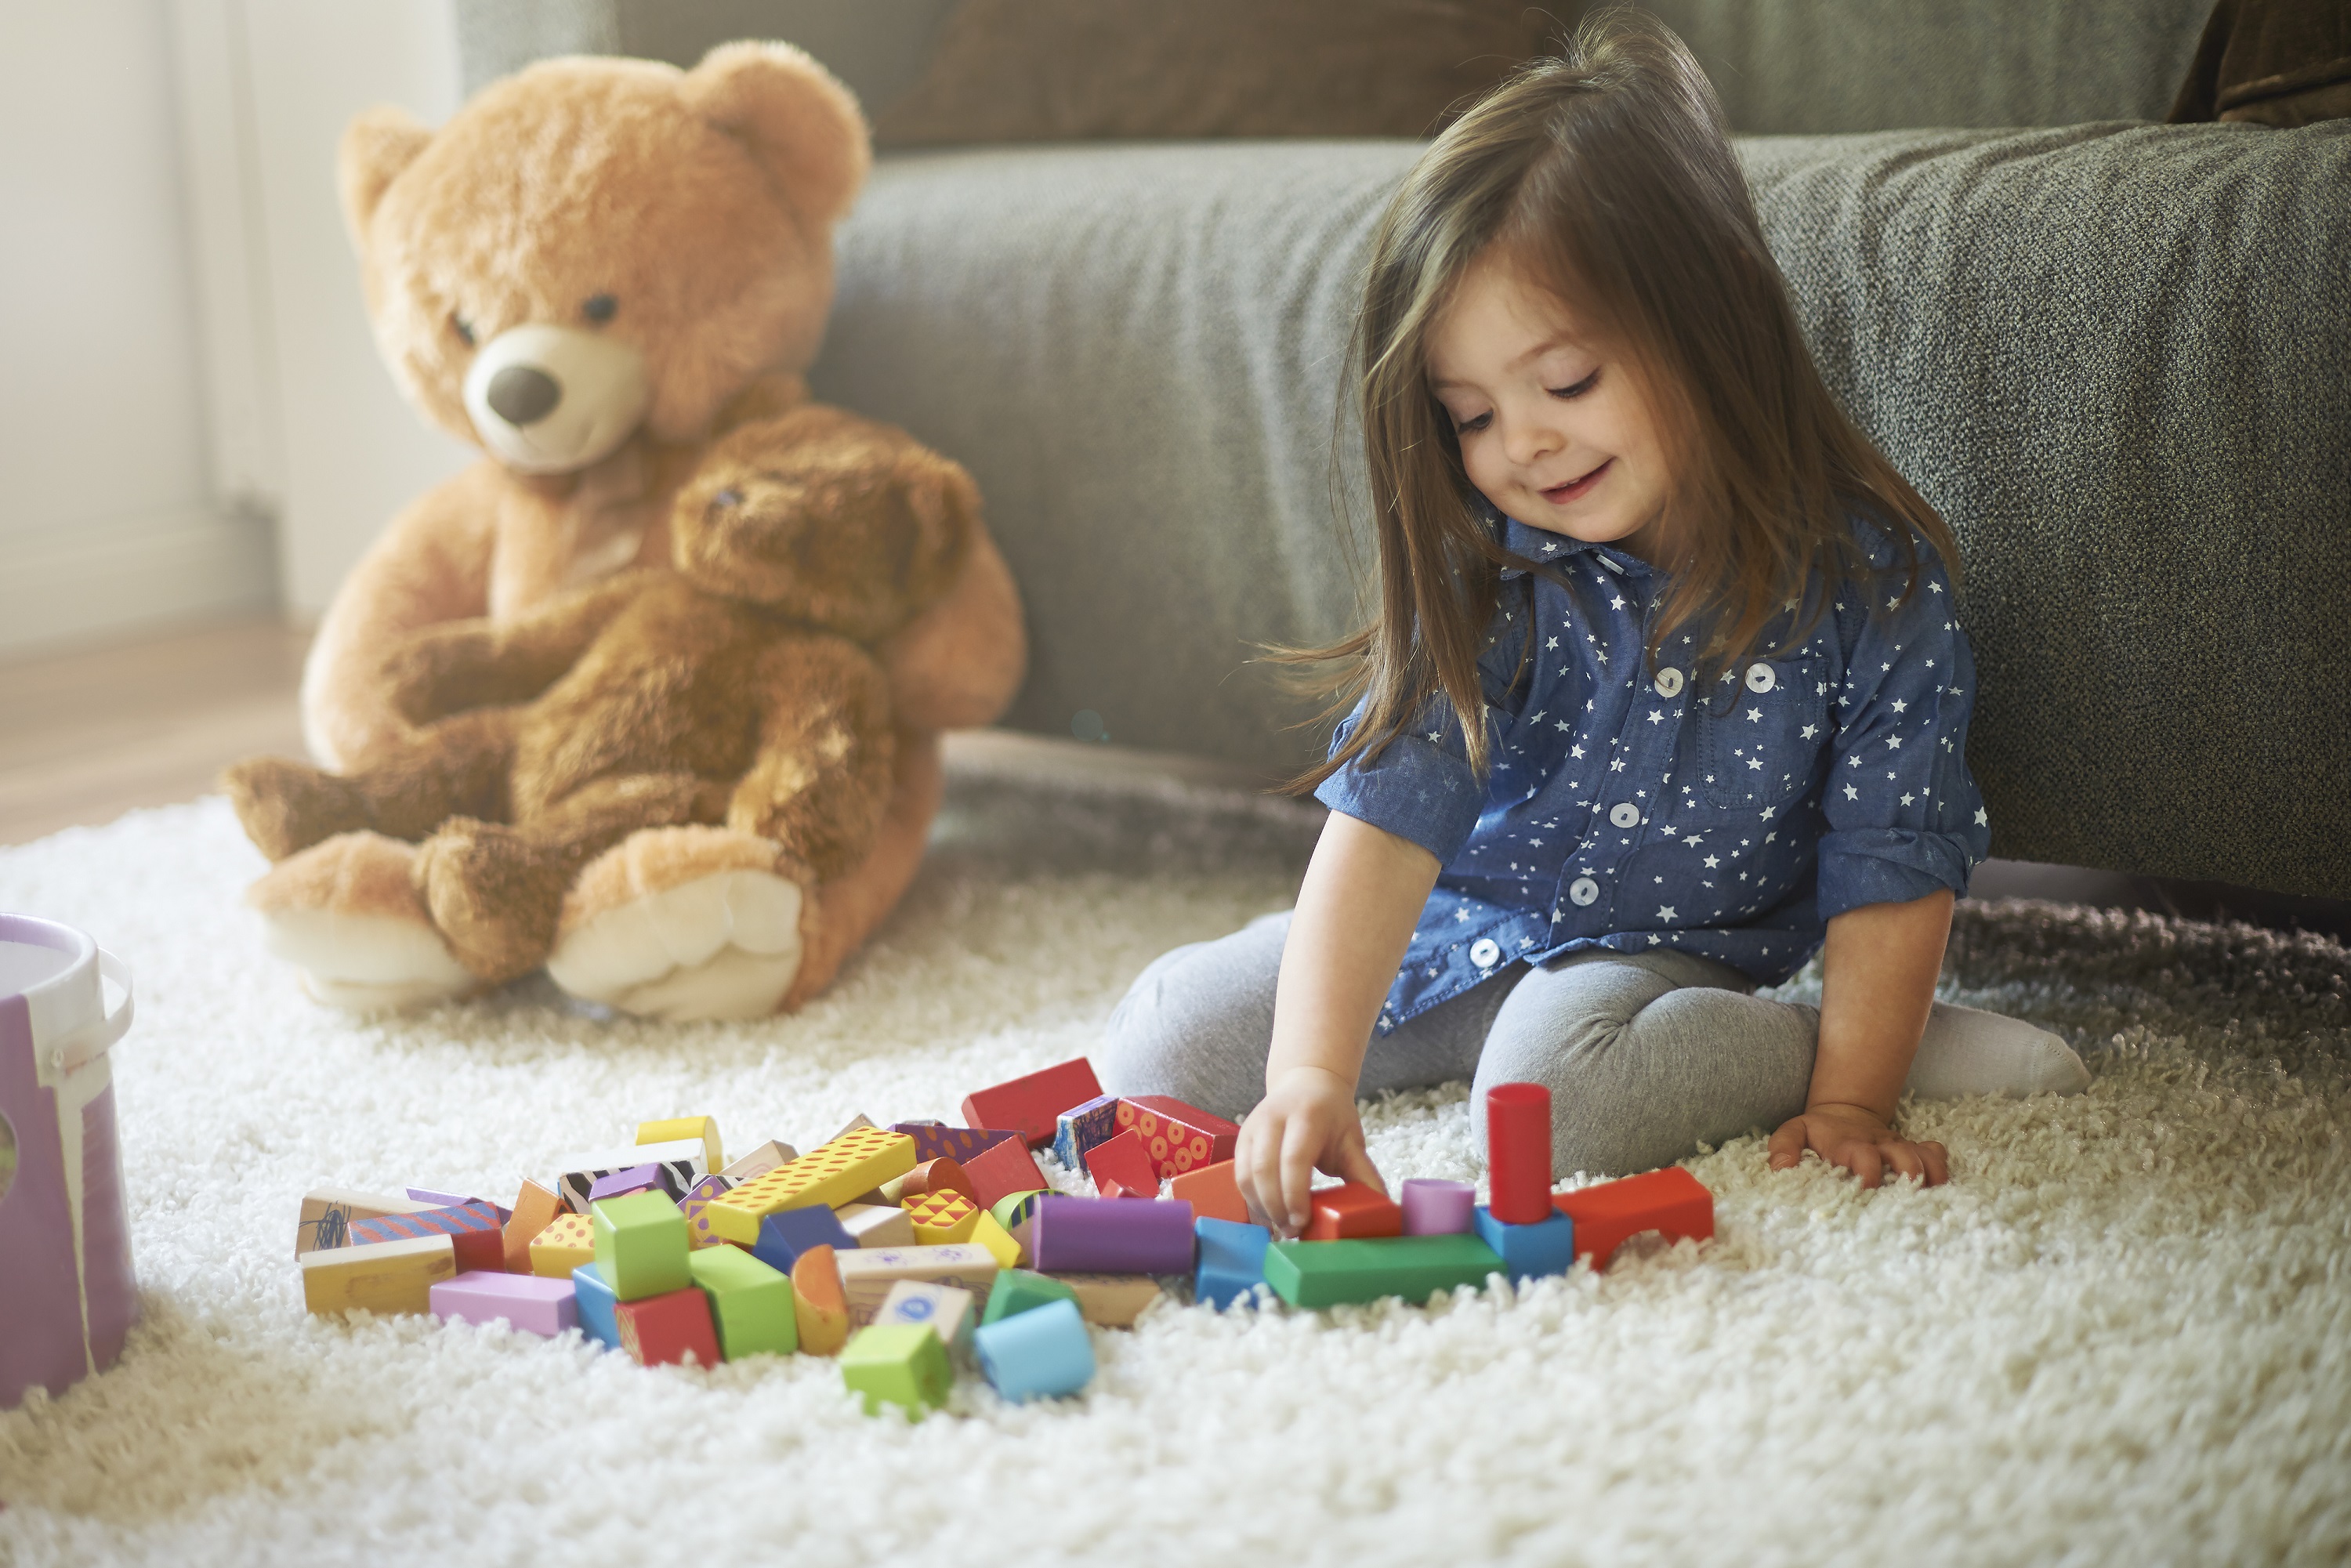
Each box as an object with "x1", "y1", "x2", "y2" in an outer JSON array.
[{"x1": 1103, "y1": 914, "x2": 2090, "y2": 1175}]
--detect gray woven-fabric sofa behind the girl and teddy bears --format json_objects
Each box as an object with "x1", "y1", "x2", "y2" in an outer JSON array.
[{"x1": 458, "y1": 0, "x2": 2351, "y2": 898}]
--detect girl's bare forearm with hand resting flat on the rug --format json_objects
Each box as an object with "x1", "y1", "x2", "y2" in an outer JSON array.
[{"x1": 1768, "y1": 891, "x2": 1951, "y2": 1187}]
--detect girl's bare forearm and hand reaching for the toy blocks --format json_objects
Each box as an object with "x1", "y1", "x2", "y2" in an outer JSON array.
[{"x1": 1234, "y1": 811, "x2": 1439, "y2": 1237}]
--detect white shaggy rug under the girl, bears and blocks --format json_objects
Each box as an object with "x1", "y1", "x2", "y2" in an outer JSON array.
[{"x1": 0, "y1": 766, "x2": 2351, "y2": 1568}]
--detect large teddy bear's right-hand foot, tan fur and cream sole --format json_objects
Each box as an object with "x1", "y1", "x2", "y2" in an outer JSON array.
[{"x1": 548, "y1": 827, "x2": 811, "y2": 1020}]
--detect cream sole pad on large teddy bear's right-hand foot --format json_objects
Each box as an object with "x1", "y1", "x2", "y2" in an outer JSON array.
[{"x1": 548, "y1": 867, "x2": 804, "y2": 1020}]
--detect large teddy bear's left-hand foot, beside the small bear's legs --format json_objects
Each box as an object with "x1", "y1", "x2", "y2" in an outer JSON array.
[{"x1": 245, "y1": 832, "x2": 477, "y2": 1013}]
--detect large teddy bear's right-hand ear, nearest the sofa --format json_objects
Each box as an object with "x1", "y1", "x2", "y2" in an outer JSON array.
[{"x1": 686, "y1": 42, "x2": 872, "y2": 223}]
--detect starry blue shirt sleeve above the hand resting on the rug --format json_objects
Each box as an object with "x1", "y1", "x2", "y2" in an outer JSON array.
[{"x1": 1820, "y1": 559, "x2": 1991, "y2": 919}]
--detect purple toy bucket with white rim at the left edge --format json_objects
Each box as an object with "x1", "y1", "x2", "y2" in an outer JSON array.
[{"x1": 0, "y1": 914, "x2": 139, "y2": 1410}]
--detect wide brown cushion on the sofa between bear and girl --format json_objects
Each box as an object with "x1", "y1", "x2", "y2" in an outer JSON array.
[{"x1": 875, "y1": 0, "x2": 1566, "y2": 146}]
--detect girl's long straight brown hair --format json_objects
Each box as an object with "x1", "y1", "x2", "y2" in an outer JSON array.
[{"x1": 1272, "y1": 9, "x2": 1958, "y2": 792}]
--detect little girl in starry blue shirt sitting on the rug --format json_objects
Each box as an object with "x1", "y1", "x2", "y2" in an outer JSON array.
[{"x1": 1103, "y1": 12, "x2": 2088, "y2": 1234}]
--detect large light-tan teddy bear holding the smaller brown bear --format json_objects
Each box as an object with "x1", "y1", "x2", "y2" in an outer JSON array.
[{"x1": 240, "y1": 45, "x2": 1025, "y2": 1018}]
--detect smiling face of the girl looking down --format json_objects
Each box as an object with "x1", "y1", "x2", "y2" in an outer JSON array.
[{"x1": 1429, "y1": 259, "x2": 1667, "y2": 557}]
